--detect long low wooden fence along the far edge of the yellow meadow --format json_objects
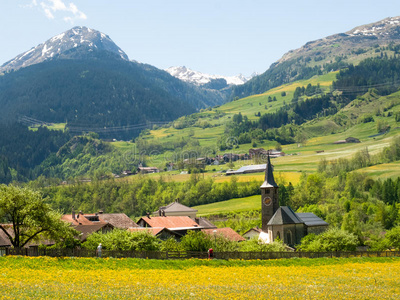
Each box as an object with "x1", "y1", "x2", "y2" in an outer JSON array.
[{"x1": 0, "y1": 248, "x2": 400, "y2": 260}]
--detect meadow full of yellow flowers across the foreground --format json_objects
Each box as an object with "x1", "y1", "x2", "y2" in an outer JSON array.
[{"x1": 0, "y1": 256, "x2": 400, "y2": 300}]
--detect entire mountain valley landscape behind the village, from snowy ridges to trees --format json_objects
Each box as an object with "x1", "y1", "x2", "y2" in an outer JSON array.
[{"x1": 0, "y1": 18, "x2": 400, "y2": 255}]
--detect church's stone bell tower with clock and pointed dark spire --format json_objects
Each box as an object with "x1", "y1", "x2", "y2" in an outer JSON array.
[{"x1": 260, "y1": 154, "x2": 279, "y2": 232}]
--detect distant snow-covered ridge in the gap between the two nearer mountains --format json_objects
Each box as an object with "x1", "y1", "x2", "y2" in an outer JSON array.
[{"x1": 165, "y1": 66, "x2": 250, "y2": 85}]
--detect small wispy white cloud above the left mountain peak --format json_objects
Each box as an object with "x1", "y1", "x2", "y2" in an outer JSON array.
[{"x1": 21, "y1": 0, "x2": 87, "y2": 23}]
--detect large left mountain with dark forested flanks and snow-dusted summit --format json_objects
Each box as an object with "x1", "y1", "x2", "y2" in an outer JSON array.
[{"x1": 0, "y1": 27, "x2": 225, "y2": 139}]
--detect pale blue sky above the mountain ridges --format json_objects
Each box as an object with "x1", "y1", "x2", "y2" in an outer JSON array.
[{"x1": 0, "y1": 0, "x2": 400, "y2": 76}]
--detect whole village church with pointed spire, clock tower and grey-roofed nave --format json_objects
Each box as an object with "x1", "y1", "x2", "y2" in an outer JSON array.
[{"x1": 260, "y1": 156, "x2": 328, "y2": 246}]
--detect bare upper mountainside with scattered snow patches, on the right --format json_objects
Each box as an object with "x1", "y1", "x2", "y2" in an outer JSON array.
[{"x1": 231, "y1": 17, "x2": 400, "y2": 99}]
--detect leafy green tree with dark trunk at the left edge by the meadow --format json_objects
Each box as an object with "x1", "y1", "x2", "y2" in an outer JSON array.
[{"x1": 0, "y1": 185, "x2": 77, "y2": 248}]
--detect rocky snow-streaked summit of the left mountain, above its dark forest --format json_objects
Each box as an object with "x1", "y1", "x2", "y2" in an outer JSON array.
[{"x1": 0, "y1": 26, "x2": 128, "y2": 72}]
